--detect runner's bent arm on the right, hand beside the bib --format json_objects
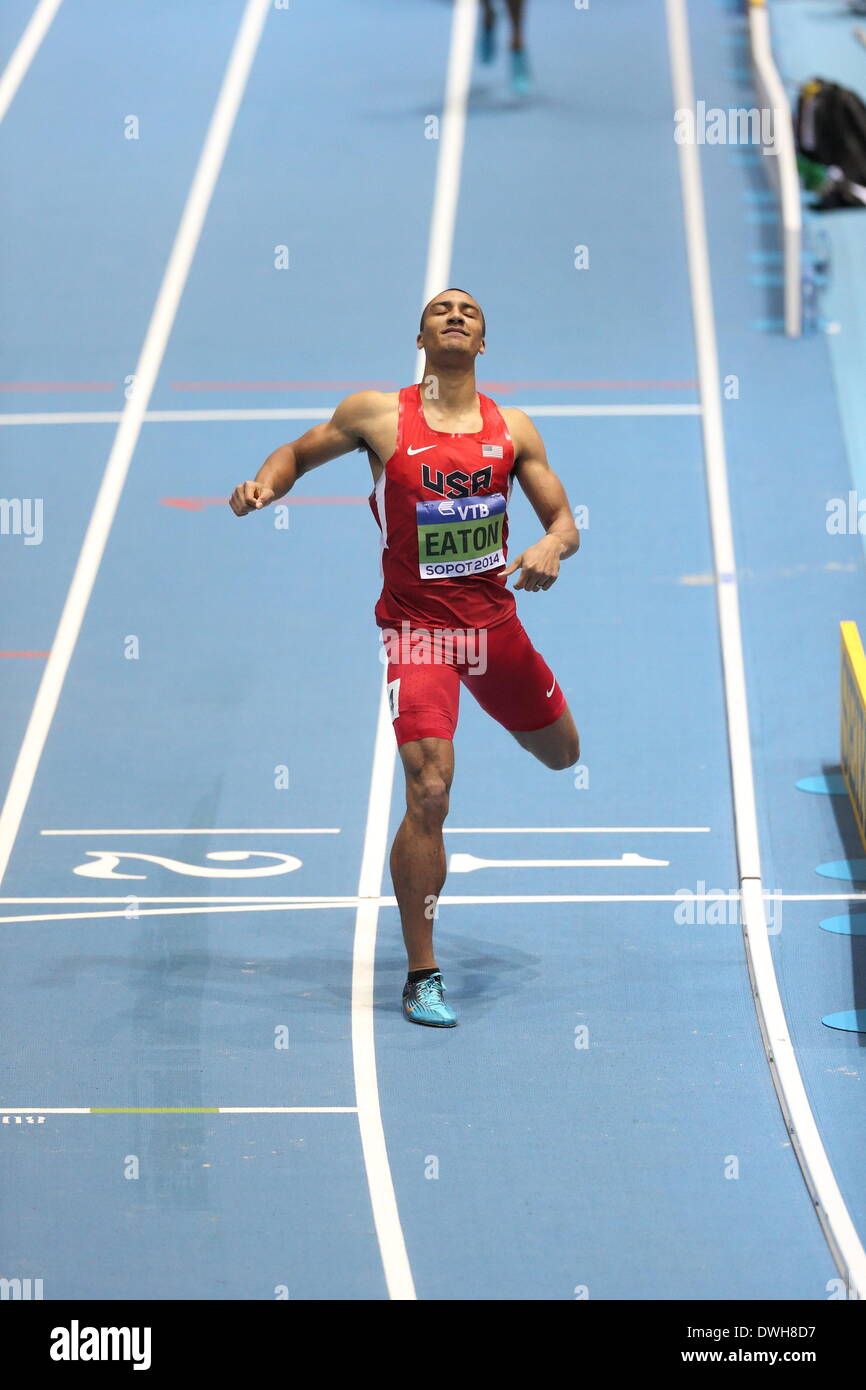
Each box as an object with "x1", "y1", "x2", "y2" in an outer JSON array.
[{"x1": 503, "y1": 407, "x2": 580, "y2": 592}]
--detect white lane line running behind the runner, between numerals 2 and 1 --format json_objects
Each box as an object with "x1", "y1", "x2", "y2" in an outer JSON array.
[{"x1": 352, "y1": 0, "x2": 477, "y2": 1300}]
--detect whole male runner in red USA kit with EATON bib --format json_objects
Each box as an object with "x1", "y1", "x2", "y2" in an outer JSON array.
[{"x1": 229, "y1": 289, "x2": 580, "y2": 1029}]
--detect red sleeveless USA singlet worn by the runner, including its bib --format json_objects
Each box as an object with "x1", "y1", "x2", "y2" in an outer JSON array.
[{"x1": 370, "y1": 385, "x2": 516, "y2": 628}]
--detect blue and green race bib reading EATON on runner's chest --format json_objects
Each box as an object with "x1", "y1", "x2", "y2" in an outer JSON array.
[{"x1": 416, "y1": 492, "x2": 505, "y2": 580}]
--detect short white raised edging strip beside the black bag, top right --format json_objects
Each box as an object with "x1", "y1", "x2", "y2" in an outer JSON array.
[{"x1": 749, "y1": 0, "x2": 802, "y2": 338}]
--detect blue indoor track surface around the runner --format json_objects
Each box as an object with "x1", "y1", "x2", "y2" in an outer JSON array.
[{"x1": 0, "y1": 0, "x2": 866, "y2": 1301}]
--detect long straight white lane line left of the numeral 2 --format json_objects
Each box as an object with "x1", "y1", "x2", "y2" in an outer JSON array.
[{"x1": 0, "y1": 0, "x2": 271, "y2": 883}]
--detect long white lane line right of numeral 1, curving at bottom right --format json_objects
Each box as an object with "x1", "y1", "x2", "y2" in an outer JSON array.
[{"x1": 666, "y1": 0, "x2": 866, "y2": 1298}]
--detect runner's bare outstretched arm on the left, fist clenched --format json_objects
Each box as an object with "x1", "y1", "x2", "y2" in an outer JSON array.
[{"x1": 228, "y1": 391, "x2": 381, "y2": 517}]
